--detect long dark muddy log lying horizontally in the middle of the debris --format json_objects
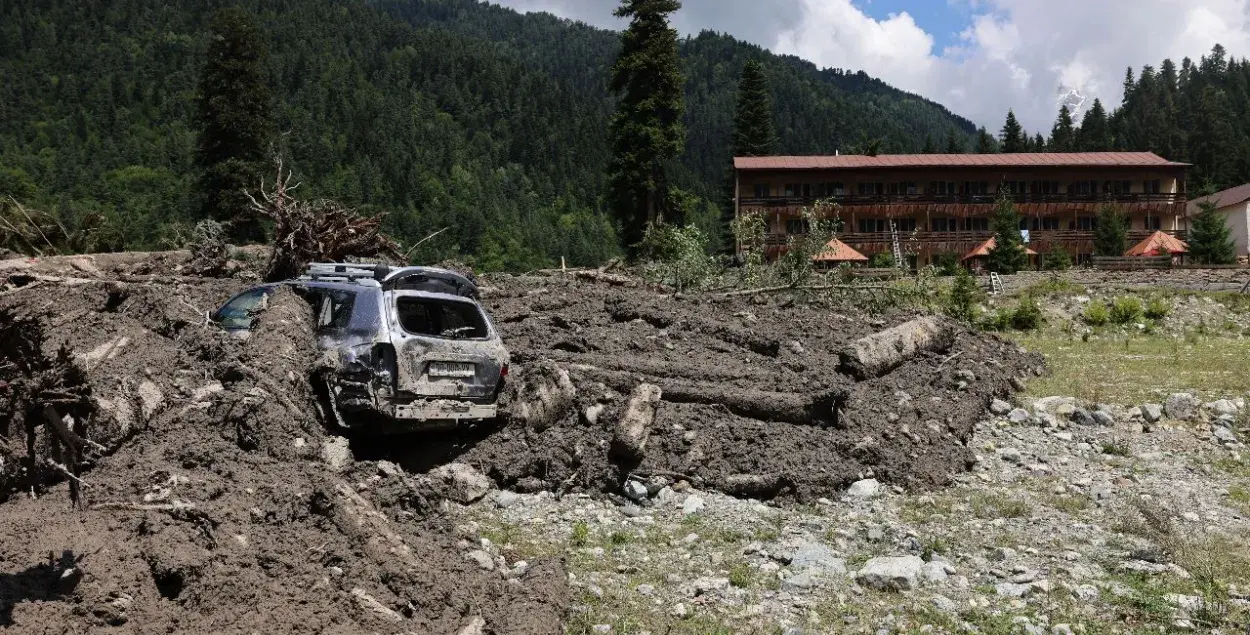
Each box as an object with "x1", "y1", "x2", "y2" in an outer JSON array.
[{"x1": 570, "y1": 366, "x2": 848, "y2": 426}]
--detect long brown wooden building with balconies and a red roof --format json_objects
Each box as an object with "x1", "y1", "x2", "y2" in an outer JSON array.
[{"x1": 734, "y1": 153, "x2": 1189, "y2": 266}]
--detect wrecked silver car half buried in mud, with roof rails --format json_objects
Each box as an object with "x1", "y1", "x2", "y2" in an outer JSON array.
[{"x1": 209, "y1": 264, "x2": 509, "y2": 431}]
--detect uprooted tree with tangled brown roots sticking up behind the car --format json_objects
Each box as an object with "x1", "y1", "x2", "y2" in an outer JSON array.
[{"x1": 245, "y1": 158, "x2": 404, "y2": 283}]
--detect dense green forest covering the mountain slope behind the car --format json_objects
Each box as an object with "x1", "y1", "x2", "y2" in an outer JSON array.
[{"x1": 0, "y1": 0, "x2": 976, "y2": 269}]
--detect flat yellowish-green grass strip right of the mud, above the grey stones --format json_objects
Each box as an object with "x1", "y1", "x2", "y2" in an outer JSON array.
[{"x1": 1015, "y1": 331, "x2": 1250, "y2": 404}]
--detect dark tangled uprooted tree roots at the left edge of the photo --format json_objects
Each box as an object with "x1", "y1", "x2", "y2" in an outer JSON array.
[{"x1": 0, "y1": 310, "x2": 100, "y2": 506}]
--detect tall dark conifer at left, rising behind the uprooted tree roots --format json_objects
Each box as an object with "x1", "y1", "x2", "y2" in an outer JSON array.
[{"x1": 196, "y1": 8, "x2": 273, "y2": 243}]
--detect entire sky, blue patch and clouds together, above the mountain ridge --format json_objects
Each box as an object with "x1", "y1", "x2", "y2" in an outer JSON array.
[{"x1": 494, "y1": 0, "x2": 1250, "y2": 133}]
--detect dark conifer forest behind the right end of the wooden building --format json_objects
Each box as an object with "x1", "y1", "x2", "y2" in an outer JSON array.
[{"x1": 984, "y1": 45, "x2": 1250, "y2": 194}]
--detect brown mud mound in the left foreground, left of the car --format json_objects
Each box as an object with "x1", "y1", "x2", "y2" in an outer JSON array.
[{"x1": 0, "y1": 279, "x2": 568, "y2": 634}]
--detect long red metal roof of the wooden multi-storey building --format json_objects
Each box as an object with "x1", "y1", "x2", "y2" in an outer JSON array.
[{"x1": 734, "y1": 153, "x2": 1189, "y2": 170}]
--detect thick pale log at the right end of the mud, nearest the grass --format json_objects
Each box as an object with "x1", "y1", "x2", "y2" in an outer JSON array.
[{"x1": 839, "y1": 318, "x2": 955, "y2": 380}]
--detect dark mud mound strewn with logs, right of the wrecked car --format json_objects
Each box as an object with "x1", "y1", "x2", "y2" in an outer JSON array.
[{"x1": 382, "y1": 276, "x2": 1043, "y2": 500}]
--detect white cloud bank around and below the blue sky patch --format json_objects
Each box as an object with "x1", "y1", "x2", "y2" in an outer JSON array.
[{"x1": 771, "y1": 0, "x2": 1250, "y2": 134}]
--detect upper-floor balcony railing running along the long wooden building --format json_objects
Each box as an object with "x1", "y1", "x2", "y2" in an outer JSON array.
[{"x1": 739, "y1": 193, "x2": 1188, "y2": 208}]
